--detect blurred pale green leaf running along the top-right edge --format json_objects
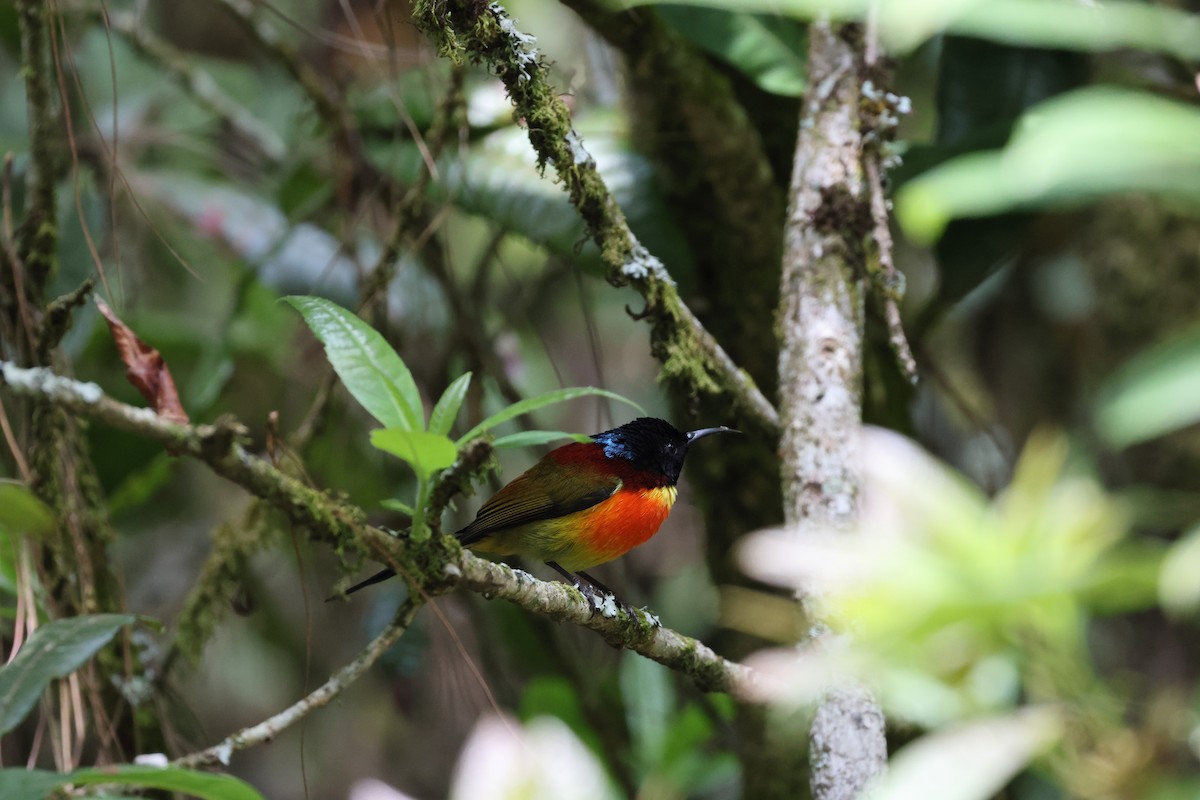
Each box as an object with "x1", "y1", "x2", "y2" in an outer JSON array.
[{"x1": 624, "y1": 0, "x2": 1200, "y2": 59}]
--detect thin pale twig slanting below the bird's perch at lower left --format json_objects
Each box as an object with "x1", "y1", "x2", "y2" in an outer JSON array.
[{"x1": 173, "y1": 597, "x2": 422, "y2": 769}]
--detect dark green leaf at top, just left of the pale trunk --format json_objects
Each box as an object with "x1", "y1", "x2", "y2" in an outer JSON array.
[{"x1": 659, "y1": 5, "x2": 806, "y2": 97}]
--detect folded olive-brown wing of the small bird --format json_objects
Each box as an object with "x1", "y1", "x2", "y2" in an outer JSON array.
[{"x1": 457, "y1": 459, "x2": 620, "y2": 545}]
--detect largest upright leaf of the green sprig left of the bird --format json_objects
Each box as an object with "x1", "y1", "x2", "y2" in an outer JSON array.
[{"x1": 284, "y1": 295, "x2": 425, "y2": 431}]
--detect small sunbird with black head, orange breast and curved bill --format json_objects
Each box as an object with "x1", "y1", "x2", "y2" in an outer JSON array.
[{"x1": 347, "y1": 417, "x2": 738, "y2": 600}]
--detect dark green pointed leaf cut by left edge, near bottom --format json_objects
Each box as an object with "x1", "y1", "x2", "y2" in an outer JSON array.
[{"x1": 0, "y1": 614, "x2": 134, "y2": 738}]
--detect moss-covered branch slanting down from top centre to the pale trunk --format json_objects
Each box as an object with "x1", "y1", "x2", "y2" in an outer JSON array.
[{"x1": 413, "y1": 0, "x2": 779, "y2": 433}]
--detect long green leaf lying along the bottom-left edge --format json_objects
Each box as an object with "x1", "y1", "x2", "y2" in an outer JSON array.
[{"x1": 0, "y1": 764, "x2": 263, "y2": 800}]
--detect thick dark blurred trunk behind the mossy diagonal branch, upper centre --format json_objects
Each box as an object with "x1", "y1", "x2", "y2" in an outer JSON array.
[{"x1": 560, "y1": 0, "x2": 794, "y2": 389}]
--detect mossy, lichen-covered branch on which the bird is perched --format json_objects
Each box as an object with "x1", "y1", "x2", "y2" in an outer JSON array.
[{"x1": 0, "y1": 361, "x2": 760, "y2": 696}]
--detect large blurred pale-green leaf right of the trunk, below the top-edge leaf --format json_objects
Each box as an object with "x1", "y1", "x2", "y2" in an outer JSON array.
[{"x1": 896, "y1": 86, "x2": 1200, "y2": 241}]
